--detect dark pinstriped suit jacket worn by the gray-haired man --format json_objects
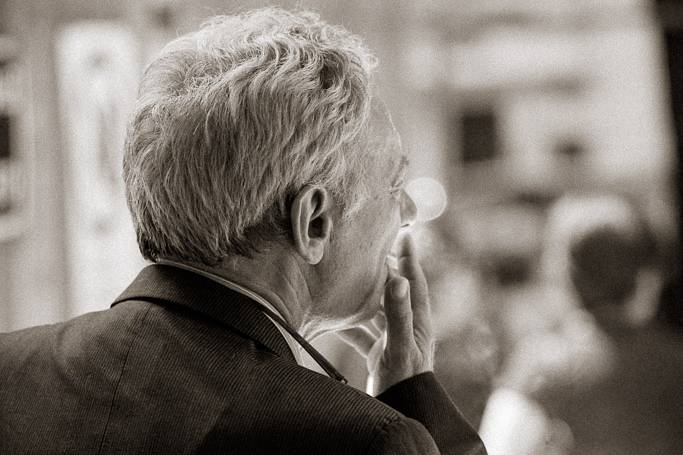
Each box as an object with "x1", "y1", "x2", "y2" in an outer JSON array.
[{"x1": 0, "y1": 265, "x2": 485, "y2": 454}]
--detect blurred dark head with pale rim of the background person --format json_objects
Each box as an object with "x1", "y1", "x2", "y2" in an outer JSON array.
[{"x1": 544, "y1": 195, "x2": 653, "y2": 309}]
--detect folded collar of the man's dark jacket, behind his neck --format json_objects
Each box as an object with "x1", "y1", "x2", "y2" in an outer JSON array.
[{"x1": 111, "y1": 264, "x2": 296, "y2": 362}]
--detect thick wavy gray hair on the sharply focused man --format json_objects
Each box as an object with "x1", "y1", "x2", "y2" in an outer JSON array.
[{"x1": 123, "y1": 8, "x2": 375, "y2": 265}]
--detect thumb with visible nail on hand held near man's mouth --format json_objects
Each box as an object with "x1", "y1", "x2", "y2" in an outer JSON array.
[{"x1": 384, "y1": 277, "x2": 413, "y2": 353}]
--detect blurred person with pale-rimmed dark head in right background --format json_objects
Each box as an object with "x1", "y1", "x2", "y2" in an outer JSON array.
[{"x1": 481, "y1": 195, "x2": 683, "y2": 454}]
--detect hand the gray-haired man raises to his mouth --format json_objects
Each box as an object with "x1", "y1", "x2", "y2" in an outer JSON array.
[{"x1": 337, "y1": 235, "x2": 434, "y2": 395}]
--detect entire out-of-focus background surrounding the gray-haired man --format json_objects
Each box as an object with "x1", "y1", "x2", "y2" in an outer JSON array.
[{"x1": 0, "y1": 0, "x2": 683, "y2": 454}]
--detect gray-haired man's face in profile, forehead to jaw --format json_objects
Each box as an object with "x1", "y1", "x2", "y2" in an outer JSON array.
[{"x1": 316, "y1": 102, "x2": 416, "y2": 332}]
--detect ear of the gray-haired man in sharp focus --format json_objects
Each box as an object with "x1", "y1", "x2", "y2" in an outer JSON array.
[{"x1": 290, "y1": 185, "x2": 334, "y2": 264}]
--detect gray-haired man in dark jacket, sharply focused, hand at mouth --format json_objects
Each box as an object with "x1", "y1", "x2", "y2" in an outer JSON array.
[{"x1": 0, "y1": 9, "x2": 485, "y2": 454}]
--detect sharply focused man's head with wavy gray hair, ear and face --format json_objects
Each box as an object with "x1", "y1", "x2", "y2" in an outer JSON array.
[{"x1": 124, "y1": 9, "x2": 415, "y2": 325}]
